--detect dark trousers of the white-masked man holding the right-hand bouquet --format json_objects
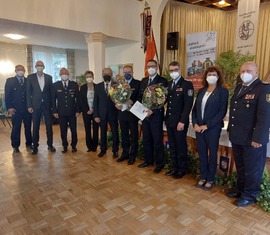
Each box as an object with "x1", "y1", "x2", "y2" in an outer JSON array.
[{"x1": 142, "y1": 119, "x2": 165, "y2": 168}]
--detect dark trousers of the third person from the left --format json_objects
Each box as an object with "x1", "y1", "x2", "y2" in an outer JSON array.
[{"x1": 59, "y1": 114, "x2": 78, "y2": 148}]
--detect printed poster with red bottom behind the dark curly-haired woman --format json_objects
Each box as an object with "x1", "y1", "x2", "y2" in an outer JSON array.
[{"x1": 186, "y1": 31, "x2": 217, "y2": 91}]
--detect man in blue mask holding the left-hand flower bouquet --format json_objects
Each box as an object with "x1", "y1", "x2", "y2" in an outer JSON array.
[{"x1": 116, "y1": 65, "x2": 140, "y2": 165}]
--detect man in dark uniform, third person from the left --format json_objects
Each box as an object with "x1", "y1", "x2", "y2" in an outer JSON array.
[{"x1": 52, "y1": 68, "x2": 80, "y2": 153}]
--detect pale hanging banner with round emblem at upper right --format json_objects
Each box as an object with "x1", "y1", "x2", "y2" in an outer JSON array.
[{"x1": 235, "y1": 0, "x2": 260, "y2": 55}]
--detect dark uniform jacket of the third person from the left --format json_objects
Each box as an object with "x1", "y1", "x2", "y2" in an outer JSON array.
[{"x1": 52, "y1": 81, "x2": 80, "y2": 116}]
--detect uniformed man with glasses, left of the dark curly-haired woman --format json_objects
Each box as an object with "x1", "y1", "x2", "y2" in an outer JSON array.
[{"x1": 165, "y1": 61, "x2": 194, "y2": 179}]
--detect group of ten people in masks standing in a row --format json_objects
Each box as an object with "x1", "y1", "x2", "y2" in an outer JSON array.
[{"x1": 5, "y1": 60, "x2": 270, "y2": 206}]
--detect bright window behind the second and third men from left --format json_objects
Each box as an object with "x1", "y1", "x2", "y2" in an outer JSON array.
[{"x1": 32, "y1": 46, "x2": 67, "y2": 82}]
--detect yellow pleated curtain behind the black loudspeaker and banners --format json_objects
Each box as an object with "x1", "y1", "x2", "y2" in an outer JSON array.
[{"x1": 161, "y1": 1, "x2": 270, "y2": 77}]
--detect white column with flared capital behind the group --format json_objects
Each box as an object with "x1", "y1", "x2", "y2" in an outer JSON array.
[{"x1": 85, "y1": 32, "x2": 107, "y2": 83}]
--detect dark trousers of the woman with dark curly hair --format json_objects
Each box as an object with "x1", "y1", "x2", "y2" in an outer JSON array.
[{"x1": 196, "y1": 128, "x2": 221, "y2": 182}]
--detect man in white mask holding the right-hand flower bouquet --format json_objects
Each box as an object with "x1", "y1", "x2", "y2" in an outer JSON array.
[{"x1": 138, "y1": 60, "x2": 168, "y2": 173}]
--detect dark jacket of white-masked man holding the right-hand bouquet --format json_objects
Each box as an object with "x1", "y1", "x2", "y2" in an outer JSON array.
[{"x1": 138, "y1": 74, "x2": 168, "y2": 122}]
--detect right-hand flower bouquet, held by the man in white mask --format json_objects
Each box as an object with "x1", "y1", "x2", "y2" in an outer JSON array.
[{"x1": 142, "y1": 84, "x2": 168, "y2": 109}]
